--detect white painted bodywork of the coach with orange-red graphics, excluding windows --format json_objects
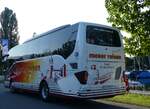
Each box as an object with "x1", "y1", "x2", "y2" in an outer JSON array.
[{"x1": 6, "y1": 23, "x2": 125, "y2": 98}]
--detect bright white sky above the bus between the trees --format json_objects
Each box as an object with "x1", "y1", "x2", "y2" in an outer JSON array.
[{"x1": 0, "y1": 0, "x2": 111, "y2": 43}]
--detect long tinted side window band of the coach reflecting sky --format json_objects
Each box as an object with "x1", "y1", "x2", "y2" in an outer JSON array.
[{"x1": 9, "y1": 25, "x2": 78, "y2": 60}]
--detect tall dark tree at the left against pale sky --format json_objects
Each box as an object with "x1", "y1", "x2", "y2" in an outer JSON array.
[{"x1": 0, "y1": 8, "x2": 19, "y2": 49}]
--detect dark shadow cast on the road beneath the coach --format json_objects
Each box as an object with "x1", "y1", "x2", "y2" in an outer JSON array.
[{"x1": 5, "y1": 91, "x2": 127, "y2": 109}]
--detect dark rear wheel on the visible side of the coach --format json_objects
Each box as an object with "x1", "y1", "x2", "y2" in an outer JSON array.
[{"x1": 40, "y1": 82, "x2": 49, "y2": 101}]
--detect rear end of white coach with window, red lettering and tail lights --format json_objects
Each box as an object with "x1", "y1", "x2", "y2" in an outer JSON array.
[{"x1": 72, "y1": 25, "x2": 125, "y2": 98}]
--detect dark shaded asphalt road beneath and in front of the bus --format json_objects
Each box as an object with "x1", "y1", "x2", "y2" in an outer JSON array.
[{"x1": 0, "y1": 84, "x2": 148, "y2": 109}]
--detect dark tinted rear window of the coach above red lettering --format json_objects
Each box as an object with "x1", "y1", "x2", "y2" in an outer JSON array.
[{"x1": 86, "y1": 26, "x2": 121, "y2": 47}]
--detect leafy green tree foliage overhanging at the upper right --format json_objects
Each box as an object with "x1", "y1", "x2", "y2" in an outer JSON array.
[{"x1": 105, "y1": 0, "x2": 150, "y2": 56}]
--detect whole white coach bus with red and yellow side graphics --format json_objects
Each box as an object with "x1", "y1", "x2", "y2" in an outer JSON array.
[{"x1": 5, "y1": 22, "x2": 125, "y2": 100}]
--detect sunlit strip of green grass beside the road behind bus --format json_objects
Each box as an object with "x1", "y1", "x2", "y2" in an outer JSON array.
[{"x1": 103, "y1": 94, "x2": 150, "y2": 107}]
